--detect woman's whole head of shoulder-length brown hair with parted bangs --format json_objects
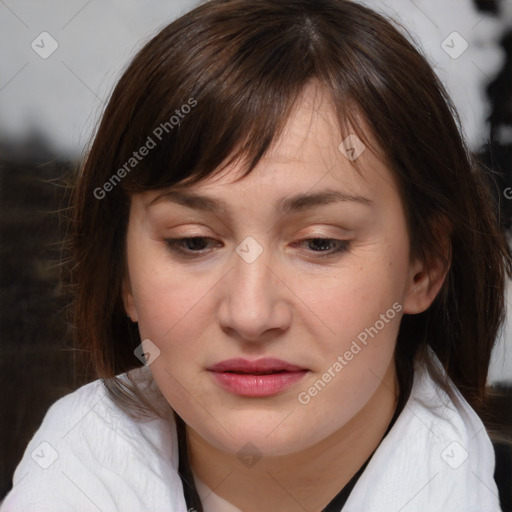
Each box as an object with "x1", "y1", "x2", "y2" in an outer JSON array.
[{"x1": 65, "y1": 0, "x2": 512, "y2": 462}]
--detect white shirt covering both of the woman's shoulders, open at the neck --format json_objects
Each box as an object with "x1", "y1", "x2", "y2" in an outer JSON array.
[{"x1": 0, "y1": 360, "x2": 500, "y2": 512}]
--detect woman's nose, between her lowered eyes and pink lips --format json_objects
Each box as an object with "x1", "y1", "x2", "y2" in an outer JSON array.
[{"x1": 218, "y1": 242, "x2": 292, "y2": 342}]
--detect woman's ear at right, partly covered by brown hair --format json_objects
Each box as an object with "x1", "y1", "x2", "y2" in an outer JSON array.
[{"x1": 403, "y1": 222, "x2": 451, "y2": 315}]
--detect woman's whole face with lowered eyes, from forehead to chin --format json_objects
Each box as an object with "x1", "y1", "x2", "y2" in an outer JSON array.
[{"x1": 124, "y1": 86, "x2": 428, "y2": 455}]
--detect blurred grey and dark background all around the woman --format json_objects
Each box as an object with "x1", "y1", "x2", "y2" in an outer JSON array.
[{"x1": 0, "y1": 0, "x2": 512, "y2": 511}]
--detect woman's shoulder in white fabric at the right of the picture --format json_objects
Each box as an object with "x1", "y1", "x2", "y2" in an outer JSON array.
[{"x1": 346, "y1": 356, "x2": 500, "y2": 512}]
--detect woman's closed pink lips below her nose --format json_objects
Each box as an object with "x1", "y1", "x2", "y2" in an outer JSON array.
[{"x1": 208, "y1": 357, "x2": 308, "y2": 397}]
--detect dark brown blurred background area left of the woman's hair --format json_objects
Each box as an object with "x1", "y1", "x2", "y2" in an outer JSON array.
[{"x1": 0, "y1": 135, "x2": 88, "y2": 499}]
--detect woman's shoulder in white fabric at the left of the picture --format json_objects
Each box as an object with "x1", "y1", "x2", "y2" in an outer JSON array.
[{"x1": 1, "y1": 368, "x2": 186, "y2": 512}]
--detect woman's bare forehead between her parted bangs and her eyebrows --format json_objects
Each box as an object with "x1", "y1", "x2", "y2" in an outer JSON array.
[{"x1": 142, "y1": 83, "x2": 402, "y2": 211}]
